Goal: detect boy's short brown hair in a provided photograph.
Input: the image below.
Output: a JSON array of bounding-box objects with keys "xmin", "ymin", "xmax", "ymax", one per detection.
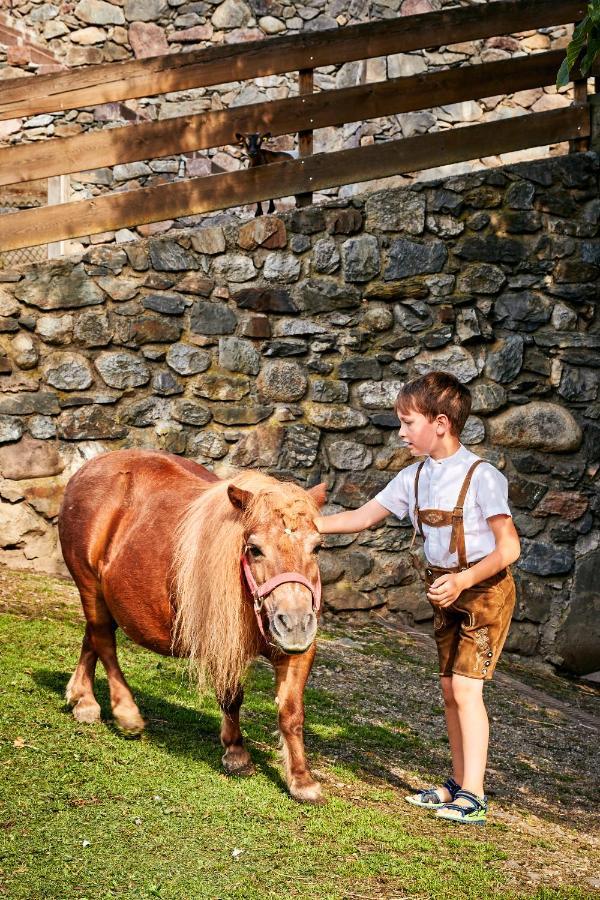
[{"xmin": 396, "ymin": 372, "xmax": 471, "ymax": 437}]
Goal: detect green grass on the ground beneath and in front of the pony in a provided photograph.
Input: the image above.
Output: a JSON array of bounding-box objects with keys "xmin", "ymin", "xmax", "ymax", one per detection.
[{"xmin": 0, "ymin": 615, "xmax": 590, "ymax": 900}]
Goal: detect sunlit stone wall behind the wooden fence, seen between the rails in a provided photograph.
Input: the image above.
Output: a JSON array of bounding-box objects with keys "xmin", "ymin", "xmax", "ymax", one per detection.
[{"xmin": 0, "ymin": 0, "xmax": 570, "ymax": 252}]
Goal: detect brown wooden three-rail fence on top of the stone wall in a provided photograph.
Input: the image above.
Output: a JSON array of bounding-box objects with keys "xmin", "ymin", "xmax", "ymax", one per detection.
[{"xmin": 0, "ymin": 0, "xmax": 590, "ymax": 250}]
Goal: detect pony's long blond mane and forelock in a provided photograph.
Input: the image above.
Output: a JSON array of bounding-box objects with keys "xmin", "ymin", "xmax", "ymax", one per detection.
[{"xmin": 173, "ymin": 470, "xmax": 317, "ymax": 700}]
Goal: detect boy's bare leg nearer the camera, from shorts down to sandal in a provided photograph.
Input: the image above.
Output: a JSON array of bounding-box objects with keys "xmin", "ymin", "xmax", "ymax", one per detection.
[{"xmin": 452, "ymin": 675, "xmax": 489, "ymax": 805}]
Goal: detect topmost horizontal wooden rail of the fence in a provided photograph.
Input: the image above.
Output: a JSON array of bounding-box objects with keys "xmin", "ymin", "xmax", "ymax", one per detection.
[{"xmin": 0, "ymin": 0, "xmax": 587, "ymax": 120}]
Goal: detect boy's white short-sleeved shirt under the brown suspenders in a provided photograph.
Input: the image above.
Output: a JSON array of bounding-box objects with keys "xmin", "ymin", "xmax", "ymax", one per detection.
[{"xmin": 375, "ymin": 444, "xmax": 511, "ymax": 569}]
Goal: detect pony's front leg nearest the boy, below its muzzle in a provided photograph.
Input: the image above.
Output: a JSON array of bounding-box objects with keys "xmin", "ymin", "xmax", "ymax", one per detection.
[{"xmin": 273, "ymin": 644, "xmax": 321, "ymax": 803}]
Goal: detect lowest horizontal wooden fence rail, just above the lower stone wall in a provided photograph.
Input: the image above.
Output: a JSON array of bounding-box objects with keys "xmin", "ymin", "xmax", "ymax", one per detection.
[{"xmin": 0, "ymin": 105, "xmax": 590, "ymax": 250}]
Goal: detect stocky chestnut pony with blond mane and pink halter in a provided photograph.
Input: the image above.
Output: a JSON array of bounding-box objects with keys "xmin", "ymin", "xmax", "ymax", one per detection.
[{"xmin": 59, "ymin": 450, "xmax": 325, "ymax": 802}]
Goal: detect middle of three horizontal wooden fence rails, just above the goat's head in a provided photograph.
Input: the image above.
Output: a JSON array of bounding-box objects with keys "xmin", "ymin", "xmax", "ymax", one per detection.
[{"xmin": 0, "ymin": 50, "xmax": 564, "ymax": 185}]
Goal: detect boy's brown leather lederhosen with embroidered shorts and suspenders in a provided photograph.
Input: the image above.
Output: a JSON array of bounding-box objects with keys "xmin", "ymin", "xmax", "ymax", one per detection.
[{"xmin": 413, "ymin": 459, "xmax": 515, "ymax": 680}]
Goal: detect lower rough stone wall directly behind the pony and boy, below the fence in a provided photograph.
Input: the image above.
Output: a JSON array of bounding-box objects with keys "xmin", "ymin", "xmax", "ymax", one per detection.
[{"xmin": 0, "ymin": 153, "xmax": 600, "ymax": 671}]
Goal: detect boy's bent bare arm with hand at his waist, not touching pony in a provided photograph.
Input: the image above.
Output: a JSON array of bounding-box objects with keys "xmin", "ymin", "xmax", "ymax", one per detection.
[{"xmin": 427, "ymin": 515, "xmax": 521, "ymax": 606}]
